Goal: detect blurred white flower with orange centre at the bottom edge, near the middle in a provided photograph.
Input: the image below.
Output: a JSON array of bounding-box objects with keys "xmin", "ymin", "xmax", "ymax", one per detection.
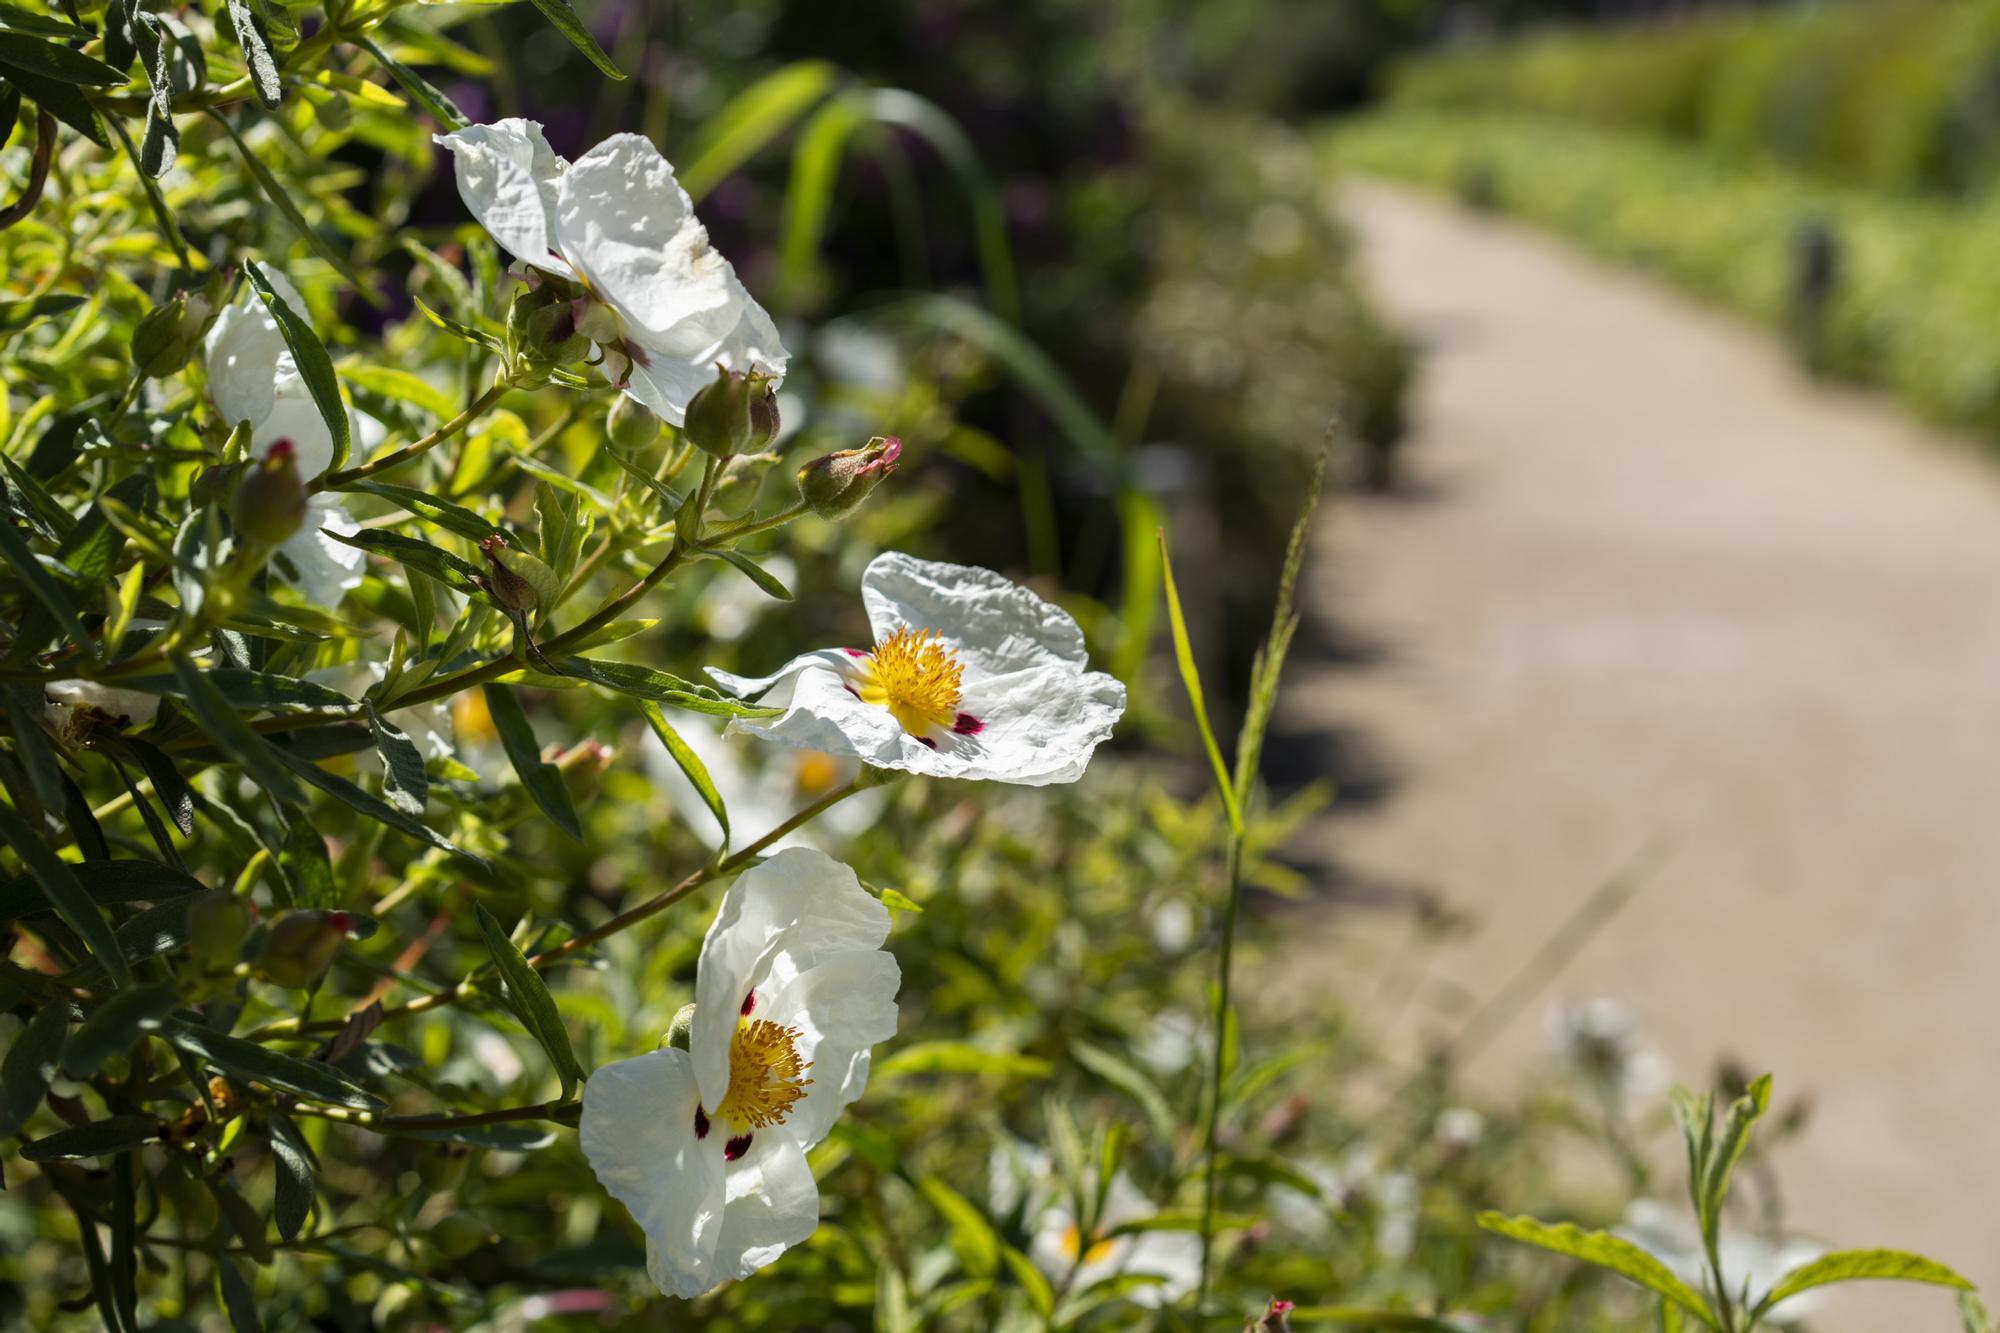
[{"xmin": 988, "ymin": 1143, "xmax": 1202, "ymax": 1309}]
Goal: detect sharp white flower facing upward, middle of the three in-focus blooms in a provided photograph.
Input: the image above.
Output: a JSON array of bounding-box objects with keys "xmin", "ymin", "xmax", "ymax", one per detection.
[{"xmin": 708, "ymin": 550, "xmax": 1124, "ymax": 787}]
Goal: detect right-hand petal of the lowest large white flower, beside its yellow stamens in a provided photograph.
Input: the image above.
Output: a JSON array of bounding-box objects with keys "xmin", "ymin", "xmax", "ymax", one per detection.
[{"xmin": 758, "ymin": 949, "xmax": 902, "ymax": 1149}]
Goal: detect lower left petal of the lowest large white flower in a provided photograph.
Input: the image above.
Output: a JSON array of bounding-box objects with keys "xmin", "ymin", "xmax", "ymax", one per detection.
[{"xmin": 576, "ymin": 1049, "xmax": 728, "ymax": 1297}]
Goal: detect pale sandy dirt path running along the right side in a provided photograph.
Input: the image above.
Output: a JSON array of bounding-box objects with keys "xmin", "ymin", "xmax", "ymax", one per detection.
[{"xmin": 1282, "ymin": 182, "xmax": 2000, "ymax": 1333}]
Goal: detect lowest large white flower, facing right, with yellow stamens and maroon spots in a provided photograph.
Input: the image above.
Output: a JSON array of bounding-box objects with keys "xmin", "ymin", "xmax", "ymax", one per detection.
[{"xmin": 578, "ymin": 849, "xmax": 902, "ymax": 1297}]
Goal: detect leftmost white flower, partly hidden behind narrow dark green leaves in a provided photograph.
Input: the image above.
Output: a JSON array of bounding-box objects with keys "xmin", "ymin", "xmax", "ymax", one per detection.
[{"xmin": 204, "ymin": 270, "xmax": 368, "ymax": 606}]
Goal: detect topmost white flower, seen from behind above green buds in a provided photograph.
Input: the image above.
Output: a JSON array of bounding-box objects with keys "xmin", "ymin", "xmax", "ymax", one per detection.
[{"xmin": 436, "ymin": 120, "xmax": 786, "ymax": 426}]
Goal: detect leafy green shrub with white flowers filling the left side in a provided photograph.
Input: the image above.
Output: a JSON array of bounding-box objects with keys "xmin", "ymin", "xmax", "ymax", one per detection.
[{"xmin": 0, "ymin": 0, "xmax": 1984, "ymax": 1333}]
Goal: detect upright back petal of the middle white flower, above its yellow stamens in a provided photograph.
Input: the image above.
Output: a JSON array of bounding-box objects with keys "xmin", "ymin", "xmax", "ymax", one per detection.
[{"xmin": 862, "ymin": 550, "xmax": 1088, "ymax": 681}]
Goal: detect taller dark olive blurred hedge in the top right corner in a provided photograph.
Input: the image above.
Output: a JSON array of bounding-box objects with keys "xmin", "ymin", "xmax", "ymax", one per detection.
[{"xmin": 1390, "ymin": 0, "xmax": 2000, "ymax": 196}]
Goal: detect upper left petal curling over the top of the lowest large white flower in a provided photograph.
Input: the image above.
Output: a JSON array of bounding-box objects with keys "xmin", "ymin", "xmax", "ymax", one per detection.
[{"xmin": 688, "ymin": 847, "xmax": 888, "ymax": 1109}]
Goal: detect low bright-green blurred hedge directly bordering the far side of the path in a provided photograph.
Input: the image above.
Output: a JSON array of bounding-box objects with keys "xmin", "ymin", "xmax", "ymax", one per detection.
[{"xmin": 1330, "ymin": 110, "xmax": 2000, "ymax": 436}]
